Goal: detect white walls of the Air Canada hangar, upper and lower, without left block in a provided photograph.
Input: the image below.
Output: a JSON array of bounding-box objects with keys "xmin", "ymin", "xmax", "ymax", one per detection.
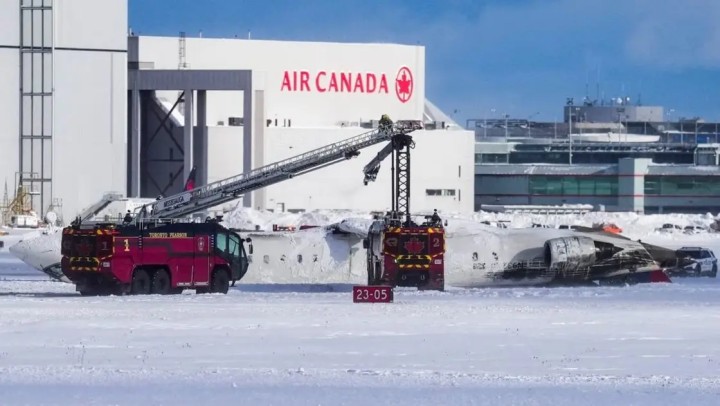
[{"xmin": 133, "ymin": 37, "xmax": 475, "ymax": 212}]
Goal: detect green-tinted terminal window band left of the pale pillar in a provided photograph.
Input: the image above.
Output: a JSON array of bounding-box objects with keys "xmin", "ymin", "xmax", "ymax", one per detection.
[{"xmin": 529, "ymin": 176, "xmax": 618, "ymax": 196}]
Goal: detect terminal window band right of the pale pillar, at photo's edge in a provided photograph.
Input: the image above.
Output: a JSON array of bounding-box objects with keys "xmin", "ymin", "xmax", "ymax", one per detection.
[{"xmin": 645, "ymin": 176, "xmax": 720, "ymax": 196}]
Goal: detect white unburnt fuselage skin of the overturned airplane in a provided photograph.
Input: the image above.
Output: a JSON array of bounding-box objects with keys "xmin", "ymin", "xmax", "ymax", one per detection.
[{"xmin": 10, "ymin": 221, "xmax": 660, "ymax": 287}]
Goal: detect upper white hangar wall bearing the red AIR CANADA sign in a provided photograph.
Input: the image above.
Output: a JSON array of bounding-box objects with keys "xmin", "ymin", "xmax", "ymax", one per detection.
[{"xmin": 133, "ymin": 36, "xmax": 425, "ymax": 127}]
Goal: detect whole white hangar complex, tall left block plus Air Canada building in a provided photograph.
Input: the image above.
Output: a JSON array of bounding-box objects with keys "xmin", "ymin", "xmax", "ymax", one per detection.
[{"xmin": 0, "ymin": 0, "xmax": 475, "ymax": 224}]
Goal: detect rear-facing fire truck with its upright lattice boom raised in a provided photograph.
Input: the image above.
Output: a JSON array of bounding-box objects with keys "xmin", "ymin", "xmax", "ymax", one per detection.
[{"xmin": 363, "ymin": 116, "xmax": 445, "ymax": 290}]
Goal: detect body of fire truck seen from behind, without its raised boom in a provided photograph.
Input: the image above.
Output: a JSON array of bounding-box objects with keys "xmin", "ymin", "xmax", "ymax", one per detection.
[{"xmin": 363, "ymin": 216, "xmax": 445, "ymax": 290}]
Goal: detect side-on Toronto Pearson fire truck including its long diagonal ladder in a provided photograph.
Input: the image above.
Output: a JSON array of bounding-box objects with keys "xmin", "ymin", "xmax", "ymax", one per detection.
[{"xmin": 61, "ymin": 116, "xmax": 418, "ymax": 295}]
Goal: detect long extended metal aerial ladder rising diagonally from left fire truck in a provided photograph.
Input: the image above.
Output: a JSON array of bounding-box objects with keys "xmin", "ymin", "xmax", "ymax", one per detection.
[{"xmin": 144, "ymin": 121, "xmax": 422, "ymax": 219}]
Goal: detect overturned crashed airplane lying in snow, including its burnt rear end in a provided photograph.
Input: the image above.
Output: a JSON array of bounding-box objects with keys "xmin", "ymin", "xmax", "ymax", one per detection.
[{"xmin": 9, "ymin": 219, "xmax": 692, "ymax": 288}]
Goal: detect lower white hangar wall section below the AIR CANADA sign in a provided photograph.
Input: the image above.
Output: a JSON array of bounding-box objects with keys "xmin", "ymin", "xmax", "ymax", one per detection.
[{"xmin": 255, "ymin": 128, "xmax": 475, "ymax": 213}]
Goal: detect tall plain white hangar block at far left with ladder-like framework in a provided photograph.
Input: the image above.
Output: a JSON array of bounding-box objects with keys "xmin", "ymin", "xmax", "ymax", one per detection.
[{"xmin": 0, "ymin": 0, "xmax": 127, "ymax": 220}]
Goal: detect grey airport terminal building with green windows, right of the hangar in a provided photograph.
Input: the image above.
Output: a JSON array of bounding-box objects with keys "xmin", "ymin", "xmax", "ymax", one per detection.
[{"xmin": 475, "ymin": 108, "xmax": 720, "ymax": 214}]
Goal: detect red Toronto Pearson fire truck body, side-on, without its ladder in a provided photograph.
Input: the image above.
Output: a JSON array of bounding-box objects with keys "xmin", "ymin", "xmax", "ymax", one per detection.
[{"xmin": 61, "ymin": 219, "xmax": 253, "ymax": 295}]
